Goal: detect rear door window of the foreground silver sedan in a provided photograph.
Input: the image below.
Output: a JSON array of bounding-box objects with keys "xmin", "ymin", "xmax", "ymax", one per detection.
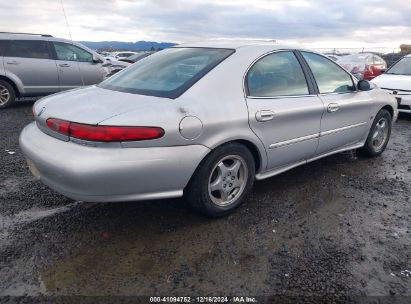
[{"xmin": 246, "ymin": 52, "xmax": 309, "ymax": 97}]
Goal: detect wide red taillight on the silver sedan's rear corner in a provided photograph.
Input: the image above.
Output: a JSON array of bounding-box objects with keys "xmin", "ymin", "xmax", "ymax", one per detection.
[{"xmin": 47, "ymin": 118, "xmax": 164, "ymax": 142}]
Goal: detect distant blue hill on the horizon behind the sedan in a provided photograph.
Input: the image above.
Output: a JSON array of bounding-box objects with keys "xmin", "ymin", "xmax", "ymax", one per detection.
[{"xmin": 79, "ymin": 41, "xmax": 176, "ymax": 51}]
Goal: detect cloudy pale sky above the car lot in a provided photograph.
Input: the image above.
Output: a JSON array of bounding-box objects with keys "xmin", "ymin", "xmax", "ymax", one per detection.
[{"xmin": 0, "ymin": 0, "xmax": 411, "ymax": 48}]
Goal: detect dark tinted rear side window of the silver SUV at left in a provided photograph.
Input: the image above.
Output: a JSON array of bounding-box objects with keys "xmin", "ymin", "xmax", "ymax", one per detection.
[{"xmin": 7, "ymin": 40, "xmax": 50, "ymax": 59}]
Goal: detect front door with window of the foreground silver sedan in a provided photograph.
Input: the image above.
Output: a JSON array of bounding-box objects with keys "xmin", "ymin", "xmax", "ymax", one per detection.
[{"xmin": 301, "ymin": 52, "xmax": 372, "ymax": 155}]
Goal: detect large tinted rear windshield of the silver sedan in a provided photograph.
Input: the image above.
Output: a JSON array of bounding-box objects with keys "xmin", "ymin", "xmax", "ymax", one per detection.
[{"xmin": 99, "ymin": 48, "xmax": 234, "ymax": 98}]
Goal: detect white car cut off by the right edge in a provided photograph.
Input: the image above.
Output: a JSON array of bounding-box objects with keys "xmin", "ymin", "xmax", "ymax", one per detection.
[{"xmin": 372, "ymin": 54, "xmax": 411, "ymax": 113}]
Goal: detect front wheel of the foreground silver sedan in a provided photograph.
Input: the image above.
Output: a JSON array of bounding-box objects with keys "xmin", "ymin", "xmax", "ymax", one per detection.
[{"xmin": 360, "ymin": 109, "xmax": 392, "ymax": 157}]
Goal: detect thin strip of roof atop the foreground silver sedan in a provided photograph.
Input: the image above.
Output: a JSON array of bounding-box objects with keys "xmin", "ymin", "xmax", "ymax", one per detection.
[{"xmin": 174, "ymin": 40, "xmax": 301, "ymax": 50}]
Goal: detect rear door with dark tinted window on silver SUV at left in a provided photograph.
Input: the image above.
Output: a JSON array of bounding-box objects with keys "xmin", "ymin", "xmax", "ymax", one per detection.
[{"xmin": 4, "ymin": 39, "xmax": 59, "ymax": 95}]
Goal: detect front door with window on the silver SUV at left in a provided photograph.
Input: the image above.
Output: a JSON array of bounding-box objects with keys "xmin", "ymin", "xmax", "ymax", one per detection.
[{"xmin": 51, "ymin": 41, "xmax": 103, "ymax": 90}]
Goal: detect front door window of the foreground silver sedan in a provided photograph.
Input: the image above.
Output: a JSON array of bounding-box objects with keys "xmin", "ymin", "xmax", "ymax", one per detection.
[{"xmin": 301, "ymin": 52, "xmax": 355, "ymax": 94}]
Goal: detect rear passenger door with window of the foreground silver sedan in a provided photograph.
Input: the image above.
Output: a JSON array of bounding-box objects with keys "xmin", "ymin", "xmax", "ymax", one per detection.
[{"xmin": 246, "ymin": 51, "xmax": 324, "ymax": 170}]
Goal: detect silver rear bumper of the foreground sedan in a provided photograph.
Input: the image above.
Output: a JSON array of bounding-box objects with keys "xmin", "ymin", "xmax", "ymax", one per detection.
[{"xmin": 20, "ymin": 123, "xmax": 209, "ymax": 202}]
